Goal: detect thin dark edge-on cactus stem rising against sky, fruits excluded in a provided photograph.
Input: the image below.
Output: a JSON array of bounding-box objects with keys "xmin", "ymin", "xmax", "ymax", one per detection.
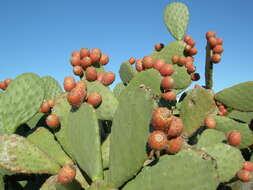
[{"xmin": 205, "ymin": 43, "xmax": 213, "ymax": 89}]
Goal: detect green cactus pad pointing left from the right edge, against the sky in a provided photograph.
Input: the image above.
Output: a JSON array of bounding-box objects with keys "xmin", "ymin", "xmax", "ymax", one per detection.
[{"xmin": 215, "ymin": 81, "xmax": 253, "ymax": 111}]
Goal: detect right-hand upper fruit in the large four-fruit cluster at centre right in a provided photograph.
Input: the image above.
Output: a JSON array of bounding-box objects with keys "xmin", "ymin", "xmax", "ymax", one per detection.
[{"xmin": 167, "ymin": 116, "xmax": 184, "ymax": 137}]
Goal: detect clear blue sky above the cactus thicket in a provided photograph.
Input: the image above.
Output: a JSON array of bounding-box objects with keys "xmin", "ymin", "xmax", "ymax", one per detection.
[{"xmin": 0, "ymin": 0, "xmax": 253, "ymax": 92}]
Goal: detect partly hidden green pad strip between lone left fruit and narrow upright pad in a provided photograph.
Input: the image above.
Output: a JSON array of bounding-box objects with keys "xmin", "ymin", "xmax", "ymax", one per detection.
[{"xmin": 52, "ymin": 94, "xmax": 72, "ymax": 155}]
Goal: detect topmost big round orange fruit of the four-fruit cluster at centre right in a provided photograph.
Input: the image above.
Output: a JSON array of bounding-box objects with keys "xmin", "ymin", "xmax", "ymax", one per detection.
[{"xmin": 152, "ymin": 107, "xmax": 172, "ymax": 130}]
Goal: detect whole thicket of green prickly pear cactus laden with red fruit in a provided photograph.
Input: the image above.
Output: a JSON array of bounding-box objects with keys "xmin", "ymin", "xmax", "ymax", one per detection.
[{"xmin": 0, "ymin": 2, "xmax": 253, "ymax": 190}]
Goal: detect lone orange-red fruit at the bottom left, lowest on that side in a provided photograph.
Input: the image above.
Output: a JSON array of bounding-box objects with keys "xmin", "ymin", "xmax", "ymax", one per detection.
[{"xmin": 57, "ymin": 165, "xmax": 76, "ymax": 184}]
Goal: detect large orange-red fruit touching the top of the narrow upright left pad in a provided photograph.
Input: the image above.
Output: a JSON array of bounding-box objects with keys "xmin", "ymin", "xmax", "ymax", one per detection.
[{"xmin": 67, "ymin": 87, "xmax": 87, "ymax": 106}]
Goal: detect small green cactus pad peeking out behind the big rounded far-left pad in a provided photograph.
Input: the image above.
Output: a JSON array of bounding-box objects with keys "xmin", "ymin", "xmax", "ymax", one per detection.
[{"xmin": 41, "ymin": 76, "xmax": 62, "ymax": 100}]
